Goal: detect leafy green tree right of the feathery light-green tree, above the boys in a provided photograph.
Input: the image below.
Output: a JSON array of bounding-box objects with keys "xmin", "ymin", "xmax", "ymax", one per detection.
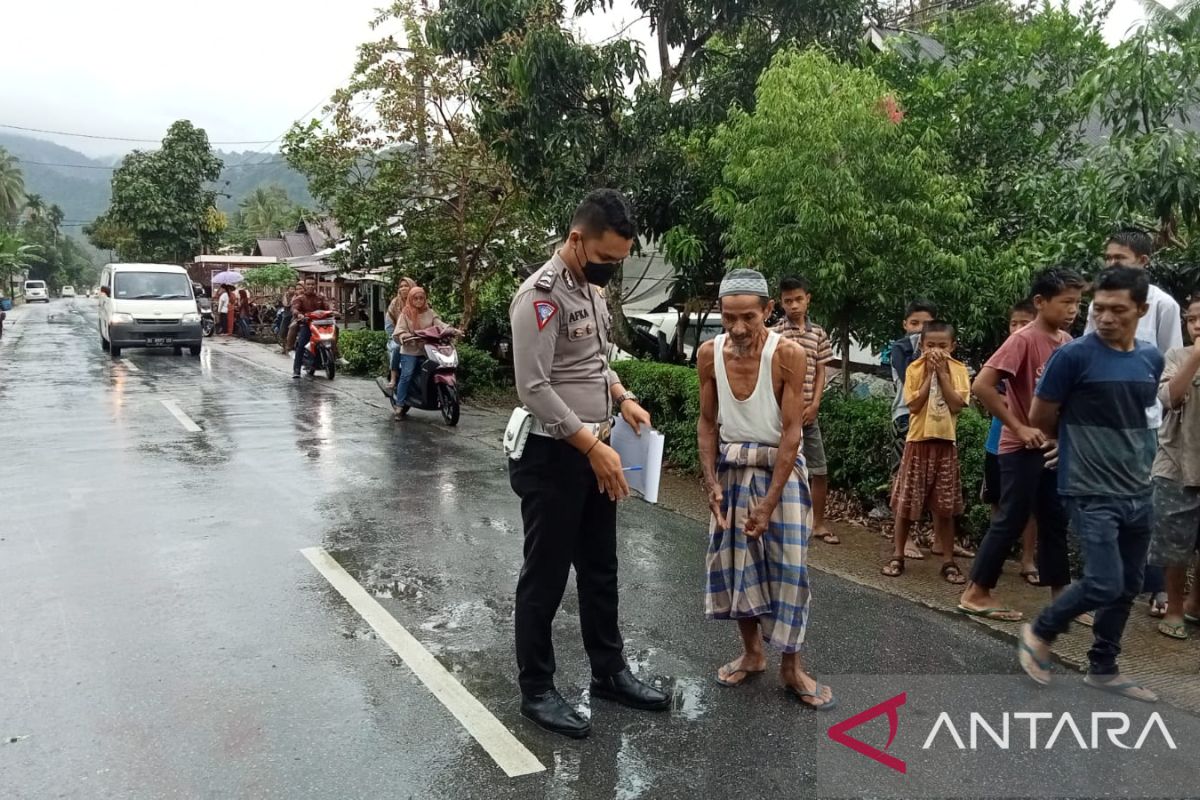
[{"xmin": 868, "ymin": 2, "xmax": 1109, "ymax": 347}]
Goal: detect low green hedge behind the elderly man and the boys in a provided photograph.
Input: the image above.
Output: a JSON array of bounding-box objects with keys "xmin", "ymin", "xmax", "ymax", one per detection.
[{"xmin": 613, "ymin": 361, "xmax": 990, "ymax": 542}]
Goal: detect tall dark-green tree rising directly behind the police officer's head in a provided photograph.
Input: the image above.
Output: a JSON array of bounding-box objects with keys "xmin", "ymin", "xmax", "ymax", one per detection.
[{"xmin": 431, "ymin": 0, "xmax": 866, "ymax": 347}]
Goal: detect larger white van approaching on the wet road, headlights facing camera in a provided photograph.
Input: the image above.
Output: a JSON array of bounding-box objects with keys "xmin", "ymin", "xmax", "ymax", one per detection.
[{"xmin": 100, "ymin": 264, "xmax": 204, "ymax": 359}]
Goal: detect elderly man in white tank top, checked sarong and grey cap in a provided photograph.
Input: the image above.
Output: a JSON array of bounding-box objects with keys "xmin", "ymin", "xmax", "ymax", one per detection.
[{"xmin": 698, "ymin": 270, "xmax": 836, "ymax": 711}]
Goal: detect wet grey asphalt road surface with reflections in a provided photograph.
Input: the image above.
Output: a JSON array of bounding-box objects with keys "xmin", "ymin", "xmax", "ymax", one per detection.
[{"xmin": 0, "ymin": 299, "xmax": 1200, "ymax": 800}]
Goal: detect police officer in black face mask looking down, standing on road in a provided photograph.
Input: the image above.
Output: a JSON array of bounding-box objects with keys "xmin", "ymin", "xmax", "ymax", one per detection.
[{"xmin": 509, "ymin": 190, "xmax": 671, "ymax": 739}]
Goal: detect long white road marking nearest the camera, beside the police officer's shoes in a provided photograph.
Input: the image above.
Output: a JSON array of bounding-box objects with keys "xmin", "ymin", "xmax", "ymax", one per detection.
[{"xmin": 300, "ymin": 547, "xmax": 546, "ymax": 777}]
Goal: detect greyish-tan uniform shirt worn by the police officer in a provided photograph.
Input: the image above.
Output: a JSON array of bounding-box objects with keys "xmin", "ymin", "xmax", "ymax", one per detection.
[{"xmin": 509, "ymin": 253, "xmax": 617, "ymax": 439}]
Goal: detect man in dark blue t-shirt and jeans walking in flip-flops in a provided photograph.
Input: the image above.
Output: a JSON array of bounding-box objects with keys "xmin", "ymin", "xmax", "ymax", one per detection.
[{"xmin": 1018, "ymin": 267, "xmax": 1163, "ymax": 703}]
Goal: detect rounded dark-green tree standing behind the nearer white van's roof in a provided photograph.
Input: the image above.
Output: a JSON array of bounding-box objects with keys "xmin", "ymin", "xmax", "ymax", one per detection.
[{"xmin": 85, "ymin": 120, "xmax": 221, "ymax": 263}]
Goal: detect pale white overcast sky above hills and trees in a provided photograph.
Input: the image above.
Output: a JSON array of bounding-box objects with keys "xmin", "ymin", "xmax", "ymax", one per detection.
[{"xmin": 0, "ymin": 0, "xmax": 1139, "ymax": 156}]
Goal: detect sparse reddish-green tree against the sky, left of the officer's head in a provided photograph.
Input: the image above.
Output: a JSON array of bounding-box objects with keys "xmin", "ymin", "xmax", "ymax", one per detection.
[{"xmin": 283, "ymin": 1, "xmax": 546, "ymax": 327}]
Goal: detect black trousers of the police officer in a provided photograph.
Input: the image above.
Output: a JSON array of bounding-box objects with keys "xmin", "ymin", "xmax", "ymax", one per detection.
[{"xmin": 509, "ymin": 435, "xmax": 625, "ymax": 696}]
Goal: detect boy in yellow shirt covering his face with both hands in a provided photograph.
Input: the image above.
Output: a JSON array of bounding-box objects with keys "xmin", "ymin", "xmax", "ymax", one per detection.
[{"xmin": 883, "ymin": 320, "xmax": 971, "ymax": 584}]
